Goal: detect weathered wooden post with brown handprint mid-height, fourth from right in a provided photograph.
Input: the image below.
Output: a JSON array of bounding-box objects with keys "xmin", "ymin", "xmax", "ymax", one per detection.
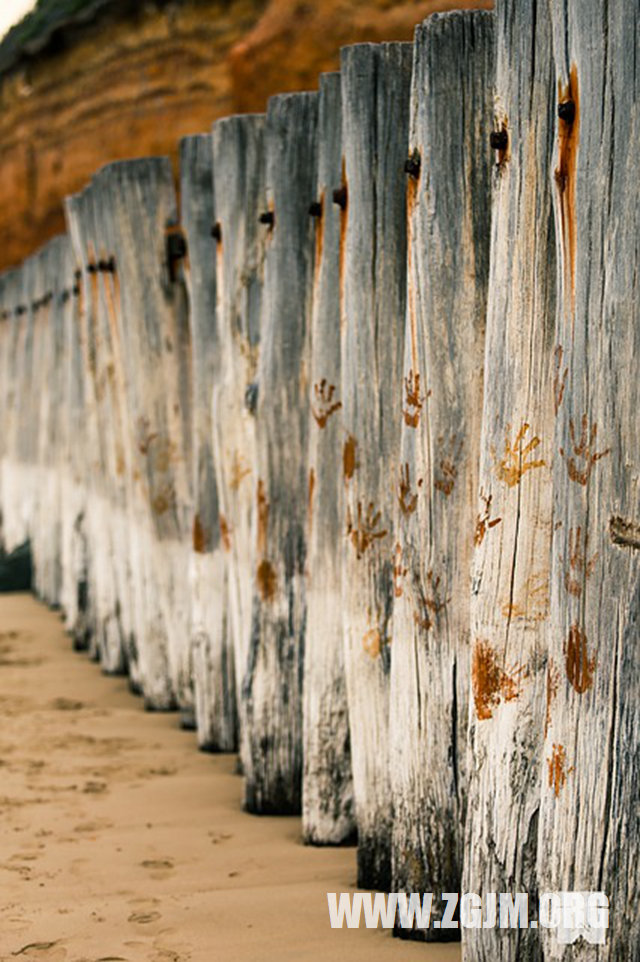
[{"xmin": 334, "ymin": 43, "xmax": 412, "ymax": 891}]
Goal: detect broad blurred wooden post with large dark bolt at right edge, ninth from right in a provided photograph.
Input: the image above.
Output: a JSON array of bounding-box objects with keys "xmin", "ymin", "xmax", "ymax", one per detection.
[{"xmin": 90, "ymin": 158, "xmax": 193, "ymax": 711}]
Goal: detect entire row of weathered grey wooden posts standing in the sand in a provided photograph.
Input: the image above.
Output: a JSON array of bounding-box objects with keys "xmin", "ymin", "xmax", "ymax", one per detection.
[{"xmin": 0, "ymin": 0, "xmax": 640, "ymax": 962}]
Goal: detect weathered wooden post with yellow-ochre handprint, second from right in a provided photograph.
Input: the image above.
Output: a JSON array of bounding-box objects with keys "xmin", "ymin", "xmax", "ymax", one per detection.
[{"xmin": 463, "ymin": 0, "xmax": 556, "ymax": 962}]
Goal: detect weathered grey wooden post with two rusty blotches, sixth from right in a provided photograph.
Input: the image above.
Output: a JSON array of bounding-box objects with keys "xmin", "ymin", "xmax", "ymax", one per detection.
[{"xmin": 244, "ymin": 93, "xmax": 318, "ymax": 814}]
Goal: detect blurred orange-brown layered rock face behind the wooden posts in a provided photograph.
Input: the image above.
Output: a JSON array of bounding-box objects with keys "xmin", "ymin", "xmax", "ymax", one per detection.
[{"xmin": 0, "ymin": 0, "xmax": 491, "ymax": 270}]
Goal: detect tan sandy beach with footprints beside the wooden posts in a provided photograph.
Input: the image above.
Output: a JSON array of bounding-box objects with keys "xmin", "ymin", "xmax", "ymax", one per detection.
[{"xmin": 0, "ymin": 595, "xmax": 460, "ymax": 962}]
